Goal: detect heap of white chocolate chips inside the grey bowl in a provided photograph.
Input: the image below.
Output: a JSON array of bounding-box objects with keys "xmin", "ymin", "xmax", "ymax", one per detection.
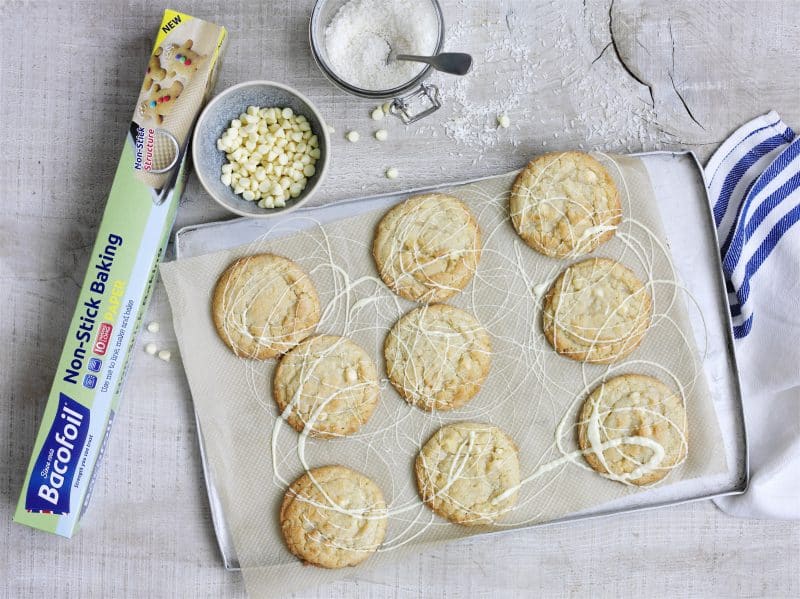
[{"xmin": 217, "ymin": 106, "xmax": 322, "ymax": 208}]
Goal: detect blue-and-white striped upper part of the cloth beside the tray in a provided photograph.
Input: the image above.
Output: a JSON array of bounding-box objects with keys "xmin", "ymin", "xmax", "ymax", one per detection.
[{"xmin": 706, "ymin": 112, "xmax": 800, "ymax": 339}]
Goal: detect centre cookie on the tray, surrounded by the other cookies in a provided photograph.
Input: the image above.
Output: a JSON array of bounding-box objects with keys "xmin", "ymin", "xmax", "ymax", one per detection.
[{"xmin": 383, "ymin": 304, "xmax": 492, "ymax": 411}]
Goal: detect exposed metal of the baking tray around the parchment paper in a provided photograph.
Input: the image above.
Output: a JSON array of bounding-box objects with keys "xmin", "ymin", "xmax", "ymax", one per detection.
[{"xmin": 175, "ymin": 151, "xmax": 748, "ymax": 570}]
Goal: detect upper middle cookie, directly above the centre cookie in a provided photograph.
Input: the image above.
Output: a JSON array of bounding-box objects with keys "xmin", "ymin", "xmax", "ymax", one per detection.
[{"xmin": 372, "ymin": 193, "xmax": 481, "ymax": 304}]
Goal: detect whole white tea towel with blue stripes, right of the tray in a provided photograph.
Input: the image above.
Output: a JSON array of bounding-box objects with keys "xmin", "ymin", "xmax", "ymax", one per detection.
[{"xmin": 705, "ymin": 112, "xmax": 800, "ymax": 519}]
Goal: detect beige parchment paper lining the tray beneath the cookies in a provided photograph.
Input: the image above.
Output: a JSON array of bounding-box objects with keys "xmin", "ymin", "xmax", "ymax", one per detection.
[{"xmin": 161, "ymin": 155, "xmax": 727, "ymax": 596}]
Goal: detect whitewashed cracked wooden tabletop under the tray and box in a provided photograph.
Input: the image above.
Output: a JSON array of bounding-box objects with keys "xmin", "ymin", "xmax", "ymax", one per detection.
[{"xmin": 0, "ymin": 0, "xmax": 800, "ymax": 597}]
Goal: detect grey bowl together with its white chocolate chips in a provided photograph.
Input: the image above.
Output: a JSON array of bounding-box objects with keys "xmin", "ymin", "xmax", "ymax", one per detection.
[{"xmin": 192, "ymin": 81, "xmax": 329, "ymax": 218}]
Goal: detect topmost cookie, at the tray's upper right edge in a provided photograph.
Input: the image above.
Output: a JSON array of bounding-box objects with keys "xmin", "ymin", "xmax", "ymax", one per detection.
[{"xmin": 509, "ymin": 152, "xmax": 622, "ymax": 258}]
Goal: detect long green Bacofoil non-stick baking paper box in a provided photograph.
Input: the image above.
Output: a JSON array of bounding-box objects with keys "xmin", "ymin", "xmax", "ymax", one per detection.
[{"xmin": 14, "ymin": 10, "xmax": 226, "ymax": 537}]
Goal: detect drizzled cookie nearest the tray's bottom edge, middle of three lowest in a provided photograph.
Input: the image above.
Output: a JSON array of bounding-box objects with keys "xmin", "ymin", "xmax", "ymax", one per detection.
[{"xmin": 415, "ymin": 422, "xmax": 520, "ymax": 525}]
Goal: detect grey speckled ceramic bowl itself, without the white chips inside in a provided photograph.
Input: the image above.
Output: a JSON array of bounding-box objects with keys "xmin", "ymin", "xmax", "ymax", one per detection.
[{"xmin": 192, "ymin": 81, "xmax": 330, "ymax": 218}]
